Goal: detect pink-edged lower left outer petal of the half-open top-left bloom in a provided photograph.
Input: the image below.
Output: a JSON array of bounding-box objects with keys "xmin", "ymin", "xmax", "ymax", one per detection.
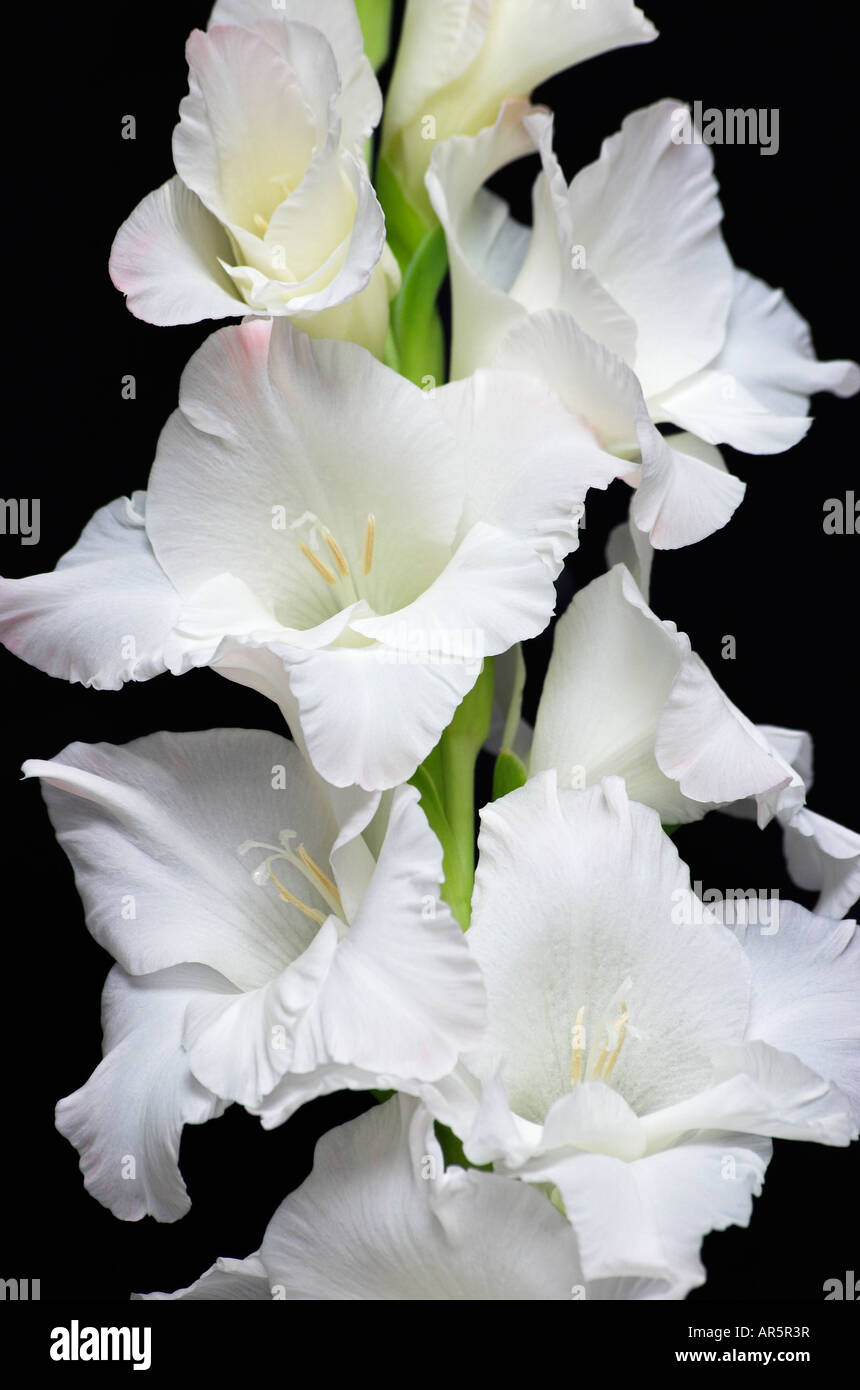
[{"xmin": 110, "ymin": 178, "xmax": 241, "ymax": 324}]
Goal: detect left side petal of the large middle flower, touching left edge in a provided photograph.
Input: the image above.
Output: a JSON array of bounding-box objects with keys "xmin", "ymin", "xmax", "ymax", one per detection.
[{"xmin": 0, "ymin": 495, "xmax": 179, "ymax": 689}]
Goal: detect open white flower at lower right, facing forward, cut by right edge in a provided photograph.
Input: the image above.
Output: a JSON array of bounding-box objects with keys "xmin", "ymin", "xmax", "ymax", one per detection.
[{"xmin": 422, "ymin": 773, "xmax": 860, "ymax": 1295}]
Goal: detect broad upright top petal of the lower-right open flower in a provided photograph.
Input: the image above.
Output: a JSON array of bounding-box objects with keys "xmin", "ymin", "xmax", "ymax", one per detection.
[{"xmin": 467, "ymin": 773, "xmax": 749, "ymax": 1123}]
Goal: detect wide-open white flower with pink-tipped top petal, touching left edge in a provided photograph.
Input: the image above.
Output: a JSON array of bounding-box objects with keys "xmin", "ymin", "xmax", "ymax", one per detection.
[{"xmin": 0, "ymin": 320, "xmax": 617, "ymax": 790}]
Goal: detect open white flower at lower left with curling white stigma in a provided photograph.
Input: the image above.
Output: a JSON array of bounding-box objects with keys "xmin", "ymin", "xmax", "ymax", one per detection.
[{"xmin": 24, "ymin": 730, "xmax": 485, "ymax": 1220}]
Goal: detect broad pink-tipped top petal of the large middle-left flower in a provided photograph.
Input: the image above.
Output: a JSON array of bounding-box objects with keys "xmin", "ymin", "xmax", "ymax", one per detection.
[{"xmin": 149, "ymin": 320, "xmax": 464, "ymax": 628}]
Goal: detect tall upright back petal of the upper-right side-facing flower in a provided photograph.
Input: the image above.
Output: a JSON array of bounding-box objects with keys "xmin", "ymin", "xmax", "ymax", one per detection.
[{"xmin": 570, "ymin": 100, "xmax": 732, "ymax": 396}]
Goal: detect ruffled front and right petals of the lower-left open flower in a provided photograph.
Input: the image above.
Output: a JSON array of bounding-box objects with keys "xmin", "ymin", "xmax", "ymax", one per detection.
[{"xmin": 185, "ymin": 787, "xmax": 483, "ymax": 1109}]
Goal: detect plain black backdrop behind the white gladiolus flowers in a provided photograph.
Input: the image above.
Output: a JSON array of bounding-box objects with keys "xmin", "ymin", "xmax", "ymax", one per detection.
[{"xmin": 0, "ymin": 0, "xmax": 860, "ymax": 1301}]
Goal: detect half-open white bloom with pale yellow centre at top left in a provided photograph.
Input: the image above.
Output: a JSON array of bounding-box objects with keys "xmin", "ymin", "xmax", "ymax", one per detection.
[{"xmin": 110, "ymin": 9, "xmax": 399, "ymax": 354}]
